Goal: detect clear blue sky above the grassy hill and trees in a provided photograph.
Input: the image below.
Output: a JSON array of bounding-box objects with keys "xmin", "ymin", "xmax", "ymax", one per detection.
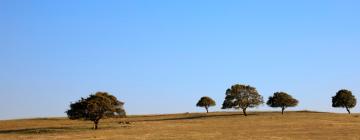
[{"xmin": 0, "ymin": 0, "xmax": 360, "ymax": 119}]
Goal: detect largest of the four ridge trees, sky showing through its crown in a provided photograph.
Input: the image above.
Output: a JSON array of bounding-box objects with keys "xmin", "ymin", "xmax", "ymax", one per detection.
[{"xmin": 222, "ymin": 84, "xmax": 264, "ymax": 116}]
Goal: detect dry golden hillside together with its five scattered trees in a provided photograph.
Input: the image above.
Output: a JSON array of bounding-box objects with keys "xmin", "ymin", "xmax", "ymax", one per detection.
[{"xmin": 0, "ymin": 84, "xmax": 360, "ymax": 140}]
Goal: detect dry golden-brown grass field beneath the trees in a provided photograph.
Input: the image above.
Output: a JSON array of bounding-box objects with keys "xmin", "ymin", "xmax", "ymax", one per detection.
[{"xmin": 0, "ymin": 111, "xmax": 360, "ymax": 140}]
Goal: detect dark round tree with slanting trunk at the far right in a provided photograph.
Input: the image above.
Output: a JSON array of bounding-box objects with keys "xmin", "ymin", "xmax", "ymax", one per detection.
[{"xmin": 332, "ymin": 89, "xmax": 356, "ymax": 114}]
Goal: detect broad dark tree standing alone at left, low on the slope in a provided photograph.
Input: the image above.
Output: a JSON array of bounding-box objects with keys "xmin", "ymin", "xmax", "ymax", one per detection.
[{"xmin": 66, "ymin": 92, "xmax": 124, "ymax": 129}]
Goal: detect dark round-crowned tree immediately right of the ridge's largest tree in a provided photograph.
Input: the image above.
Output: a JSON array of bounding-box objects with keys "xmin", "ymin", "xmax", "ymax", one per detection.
[{"xmin": 266, "ymin": 92, "xmax": 298, "ymax": 114}]
